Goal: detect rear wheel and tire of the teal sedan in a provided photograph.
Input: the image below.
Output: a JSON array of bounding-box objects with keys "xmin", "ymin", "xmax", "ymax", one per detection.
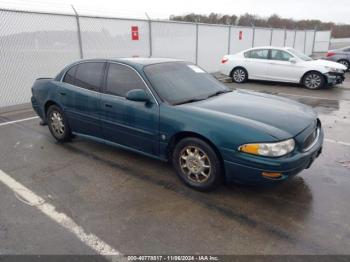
[{"xmin": 46, "ymin": 105, "xmax": 72, "ymax": 142}]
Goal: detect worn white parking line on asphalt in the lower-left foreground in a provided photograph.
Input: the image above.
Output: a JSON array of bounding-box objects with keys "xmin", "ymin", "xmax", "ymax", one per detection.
[{"xmin": 0, "ymin": 170, "xmax": 122, "ymax": 261}]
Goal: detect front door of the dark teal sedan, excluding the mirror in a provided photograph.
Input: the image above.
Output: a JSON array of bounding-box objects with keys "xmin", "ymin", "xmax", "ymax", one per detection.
[{"xmin": 101, "ymin": 63, "xmax": 159, "ymax": 155}]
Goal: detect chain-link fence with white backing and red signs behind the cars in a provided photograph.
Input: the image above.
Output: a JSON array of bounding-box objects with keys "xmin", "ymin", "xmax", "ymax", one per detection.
[{"xmin": 0, "ymin": 9, "xmax": 330, "ymax": 108}]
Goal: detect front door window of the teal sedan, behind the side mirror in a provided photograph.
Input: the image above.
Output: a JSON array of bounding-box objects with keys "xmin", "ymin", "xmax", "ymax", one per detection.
[{"xmin": 105, "ymin": 63, "xmax": 146, "ymax": 97}]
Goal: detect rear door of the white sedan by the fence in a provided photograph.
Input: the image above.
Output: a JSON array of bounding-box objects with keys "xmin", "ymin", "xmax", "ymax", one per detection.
[{"xmin": 244, "ymin": 49, "xmax": 269, "ymax": 80}]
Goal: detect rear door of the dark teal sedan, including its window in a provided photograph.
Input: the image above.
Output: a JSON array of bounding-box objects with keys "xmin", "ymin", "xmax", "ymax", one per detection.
[{"xmin": 59, "ymin": 62, "xmax": 106, "ymax": 137}]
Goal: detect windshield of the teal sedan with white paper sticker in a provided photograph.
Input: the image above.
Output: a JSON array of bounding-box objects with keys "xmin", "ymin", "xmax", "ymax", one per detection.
[{"xmin": 144, "ymin": 62, "xmax": 231, "ymax": 105}]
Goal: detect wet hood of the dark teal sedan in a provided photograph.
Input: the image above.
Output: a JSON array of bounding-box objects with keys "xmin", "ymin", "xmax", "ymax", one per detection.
[{"xmin": 183, "ymin": 90, "xmax": 317, "ymax": 140}]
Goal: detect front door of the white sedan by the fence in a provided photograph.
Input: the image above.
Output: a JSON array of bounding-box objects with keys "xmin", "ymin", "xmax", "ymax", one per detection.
[{"xmin": 266, "ymin": 49, "xmax": 303, "ymax": 83}]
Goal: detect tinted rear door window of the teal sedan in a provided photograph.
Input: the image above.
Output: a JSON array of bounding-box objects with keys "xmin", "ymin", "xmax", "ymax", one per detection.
[{"xmin": 75, "ymin": 62, "xmax": 105, "ymax": 91}]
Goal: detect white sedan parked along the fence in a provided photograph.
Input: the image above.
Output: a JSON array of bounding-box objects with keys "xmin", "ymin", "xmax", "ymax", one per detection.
[{"xmin": 220, "ymin": 46, "xmax": 346, "ymax": 89}]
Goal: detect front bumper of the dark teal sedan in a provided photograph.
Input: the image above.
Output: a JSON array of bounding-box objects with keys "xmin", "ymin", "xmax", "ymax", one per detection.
[{"xmin": 224, "ymin": 129, "xmax": 324, "ymax": 185}]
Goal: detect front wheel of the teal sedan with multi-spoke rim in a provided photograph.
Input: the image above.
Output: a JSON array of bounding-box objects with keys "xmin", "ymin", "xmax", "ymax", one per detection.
[{"xmin": 172, "ymin": 137, "xmax": 222, "ymax": 191}]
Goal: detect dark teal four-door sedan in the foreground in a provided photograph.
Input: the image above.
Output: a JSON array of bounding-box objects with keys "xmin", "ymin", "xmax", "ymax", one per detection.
[{"xmin": 31, "ymin": 58, "xmax": 323, "ymax": 190}]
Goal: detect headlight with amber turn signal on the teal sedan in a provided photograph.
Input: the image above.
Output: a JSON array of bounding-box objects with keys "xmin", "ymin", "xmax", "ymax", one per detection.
[{"xmin": 238, "ymin": 139, "xmax": 295, "ymax": 157}]
